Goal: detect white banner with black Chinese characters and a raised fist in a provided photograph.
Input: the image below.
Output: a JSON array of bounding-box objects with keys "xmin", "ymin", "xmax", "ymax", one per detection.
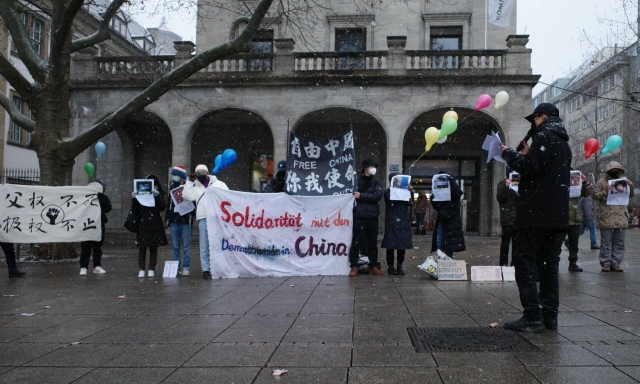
[{"xmin": 0, "ymin": 184, "xmax": 102, "ymax": 243}]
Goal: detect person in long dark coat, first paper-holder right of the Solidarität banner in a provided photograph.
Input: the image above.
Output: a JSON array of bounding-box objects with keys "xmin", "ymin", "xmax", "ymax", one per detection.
[{"xmin": 382, "ymin": 173, "xmax": 413, "ymax": 275}]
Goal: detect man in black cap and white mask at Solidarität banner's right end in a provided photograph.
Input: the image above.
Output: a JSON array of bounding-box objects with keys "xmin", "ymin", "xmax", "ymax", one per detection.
[{"xmin": 349, "ymin": 159, "xmax": 384, "ymax": 277}]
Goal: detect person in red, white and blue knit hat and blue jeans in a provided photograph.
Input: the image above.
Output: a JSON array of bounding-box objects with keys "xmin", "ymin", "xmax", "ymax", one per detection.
[{"xmin": 164, "ymin": 165, "xmax": 193, "ymax": 276}]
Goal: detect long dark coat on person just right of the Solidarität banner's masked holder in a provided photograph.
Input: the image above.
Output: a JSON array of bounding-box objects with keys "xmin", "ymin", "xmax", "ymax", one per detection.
[{"xmin": 382, "ymin": 188, "xmax": 413, "ymax": 249}]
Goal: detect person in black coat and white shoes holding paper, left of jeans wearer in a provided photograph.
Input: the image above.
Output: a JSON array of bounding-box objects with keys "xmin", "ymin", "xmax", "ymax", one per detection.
[{"xmin": 131, "ymin": 175, "xmax": 168, "ymax": 277}]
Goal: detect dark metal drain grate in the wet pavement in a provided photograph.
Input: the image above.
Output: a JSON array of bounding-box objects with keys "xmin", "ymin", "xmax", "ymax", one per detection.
[{"xmin": 407, "ymin": 327, "xmax": 540, "ymax": 353}]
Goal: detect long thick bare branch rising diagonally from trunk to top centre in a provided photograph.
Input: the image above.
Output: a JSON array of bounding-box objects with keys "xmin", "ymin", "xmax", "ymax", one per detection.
[{"xmin": 59, "ymin": 0, "xmax": 273, "ymax": 159}]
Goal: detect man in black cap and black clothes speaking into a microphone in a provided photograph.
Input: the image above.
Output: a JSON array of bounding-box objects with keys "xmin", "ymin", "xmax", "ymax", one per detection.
[{"xmin": 501, "ymin": 103, "xmax": 571, "ymax": 332}]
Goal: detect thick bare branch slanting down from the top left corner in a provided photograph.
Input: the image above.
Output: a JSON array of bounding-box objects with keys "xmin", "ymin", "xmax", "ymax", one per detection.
[{"xmin": 0, "ymin": 0, "xmax": 47, "ymax": 82}]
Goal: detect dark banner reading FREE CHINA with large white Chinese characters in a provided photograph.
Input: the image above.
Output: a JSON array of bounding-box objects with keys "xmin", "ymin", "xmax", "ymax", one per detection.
[{"xmin": 285, "ymin": 131, "xmax": 357, "ymax": 196}]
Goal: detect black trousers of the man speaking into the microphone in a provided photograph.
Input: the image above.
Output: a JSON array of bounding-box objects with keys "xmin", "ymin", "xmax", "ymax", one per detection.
[{"xmin": 513, "ymin": 228, "xmax": 560, "ymax": 320}]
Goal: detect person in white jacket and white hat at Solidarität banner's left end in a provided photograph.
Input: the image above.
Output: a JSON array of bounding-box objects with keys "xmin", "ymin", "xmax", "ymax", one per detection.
[{"xmin": 182, "ymin": 164, "xmax": 229, "ymax": 280}]
